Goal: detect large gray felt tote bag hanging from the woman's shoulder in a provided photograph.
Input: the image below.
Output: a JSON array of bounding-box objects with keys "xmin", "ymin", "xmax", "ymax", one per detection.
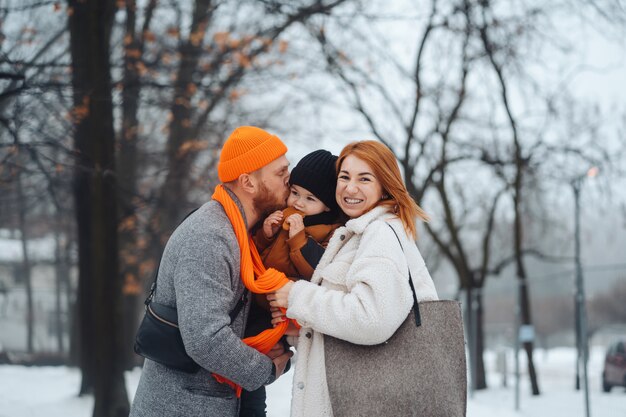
[{"xmin": 324, "ymin": 228, "xmax": 467, "ymax": 417}]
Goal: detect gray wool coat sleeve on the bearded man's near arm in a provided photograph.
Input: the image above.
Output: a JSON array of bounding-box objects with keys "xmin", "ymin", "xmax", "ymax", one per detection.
[{"xmin": 174, "ymin": 231, "xmax": 272, "ymax": 390}]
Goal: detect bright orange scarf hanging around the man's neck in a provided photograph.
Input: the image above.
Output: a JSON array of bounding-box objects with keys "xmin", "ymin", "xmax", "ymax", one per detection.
[{"xmin": 212, "ymin": 185, "xmax": 300, "ymax": 398}]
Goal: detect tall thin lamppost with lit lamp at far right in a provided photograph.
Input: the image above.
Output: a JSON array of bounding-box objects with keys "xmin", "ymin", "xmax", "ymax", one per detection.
[{"xmin": 570, "ymin": 167, "xmax": 598, "ymax": 417}]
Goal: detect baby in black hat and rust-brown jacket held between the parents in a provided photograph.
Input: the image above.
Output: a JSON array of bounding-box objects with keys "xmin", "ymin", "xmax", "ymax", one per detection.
[{"xmin": 239, "ymin": 149, "xmax": 341, "ymax": 417}]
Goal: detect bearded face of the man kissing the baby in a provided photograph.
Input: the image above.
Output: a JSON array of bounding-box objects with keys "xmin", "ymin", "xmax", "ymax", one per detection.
[{"xmin": 252, "ymin": 155, "xmax": 289, "ymax": 216}]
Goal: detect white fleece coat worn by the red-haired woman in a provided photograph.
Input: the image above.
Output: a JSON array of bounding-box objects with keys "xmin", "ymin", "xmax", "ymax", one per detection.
[{"xmin": 287, "ymin": 207, "xmax": 438, "ymax": 417}]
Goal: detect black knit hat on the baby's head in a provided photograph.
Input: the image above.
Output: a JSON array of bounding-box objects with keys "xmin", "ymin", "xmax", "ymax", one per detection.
[{"xmin": 289, "ymin": 149, "xmax": 339, "ymax": 212}]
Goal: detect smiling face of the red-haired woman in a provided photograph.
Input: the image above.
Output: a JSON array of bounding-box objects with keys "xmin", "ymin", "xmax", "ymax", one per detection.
[{"xmin": 335, "ymin": 155, "xmax": 383, "ymax": 219}]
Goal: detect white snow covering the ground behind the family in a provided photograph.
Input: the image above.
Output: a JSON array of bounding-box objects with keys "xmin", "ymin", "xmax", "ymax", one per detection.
[{"xmin": 0, "ymin": 348, "xmax": 626, "ymax": 417}]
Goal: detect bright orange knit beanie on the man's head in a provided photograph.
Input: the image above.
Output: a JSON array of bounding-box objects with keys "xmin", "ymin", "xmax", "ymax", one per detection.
[{"xmin": 217, "ymin": 126, "xmax": 287, "ymax": 182}]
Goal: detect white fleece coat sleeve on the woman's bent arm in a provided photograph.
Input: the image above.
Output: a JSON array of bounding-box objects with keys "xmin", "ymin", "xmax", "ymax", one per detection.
[{"xmin": 287, "ymin": 221, "xmax": 413, "ymax": 345}]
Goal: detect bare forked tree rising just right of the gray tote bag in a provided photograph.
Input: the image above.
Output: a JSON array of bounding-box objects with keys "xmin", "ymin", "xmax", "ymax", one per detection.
[{"xmin": 308, "ymin": 1, "xmax": 508, "ymax": 389}]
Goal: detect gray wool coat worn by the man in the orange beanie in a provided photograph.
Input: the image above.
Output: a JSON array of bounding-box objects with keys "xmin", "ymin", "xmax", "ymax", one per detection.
[{"xmin": 130, "ymin": 193, "xmax": 272, "ymax": 417}]
